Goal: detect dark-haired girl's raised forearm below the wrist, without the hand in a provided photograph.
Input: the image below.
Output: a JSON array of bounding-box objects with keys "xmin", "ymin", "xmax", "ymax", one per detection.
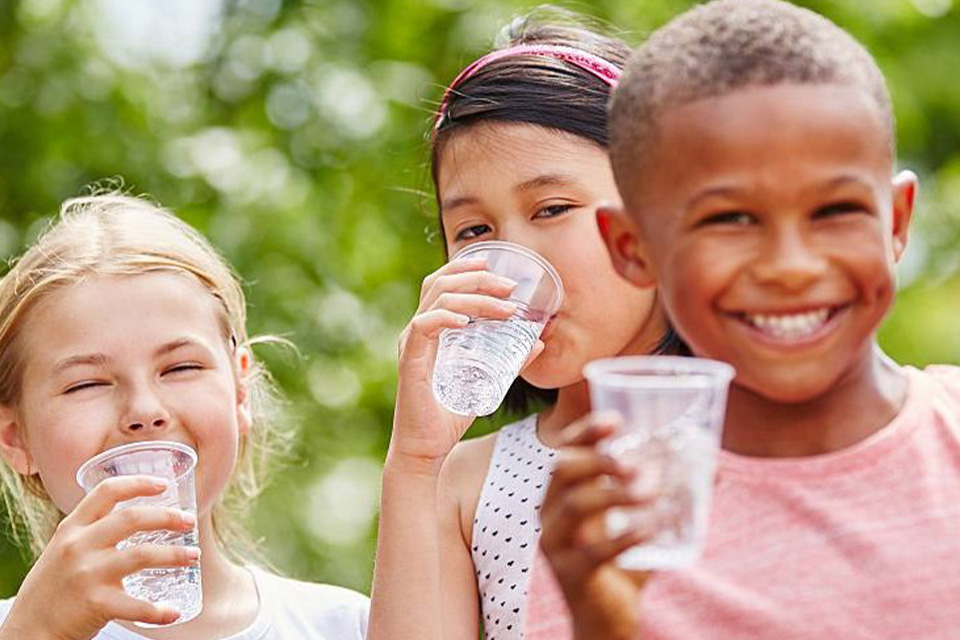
[{"xmin": 367, "ymin": 456, "xmax": 442, "ymax": 640}]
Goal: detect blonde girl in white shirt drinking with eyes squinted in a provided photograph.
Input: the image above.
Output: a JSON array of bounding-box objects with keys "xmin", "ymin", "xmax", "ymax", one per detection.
[{"xmin": 0, "ymin": 195, "xmax": 367, "ymax": 640}]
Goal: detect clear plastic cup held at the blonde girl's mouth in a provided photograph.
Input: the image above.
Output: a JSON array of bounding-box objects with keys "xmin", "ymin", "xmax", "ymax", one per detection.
[{"xmin": 77, "ymin": 441, "xmax": 203, "ymax": 627}]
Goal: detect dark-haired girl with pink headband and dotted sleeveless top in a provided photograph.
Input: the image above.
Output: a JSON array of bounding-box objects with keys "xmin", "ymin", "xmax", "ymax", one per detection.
[{"xmin": 371, "ymin": 12, "xmax": 684, "ymax": 640}]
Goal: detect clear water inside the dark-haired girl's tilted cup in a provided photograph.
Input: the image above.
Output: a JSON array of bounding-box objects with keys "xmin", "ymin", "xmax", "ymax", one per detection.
[{"xmin": 433, "ymin": 316, "xmax": 543, "ymax": 416}]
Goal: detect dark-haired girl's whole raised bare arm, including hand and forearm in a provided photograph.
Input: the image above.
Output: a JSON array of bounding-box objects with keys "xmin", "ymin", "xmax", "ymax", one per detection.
[{"xmin": 367, "ymin": 261, "xmax": 512, "ymax": 640}]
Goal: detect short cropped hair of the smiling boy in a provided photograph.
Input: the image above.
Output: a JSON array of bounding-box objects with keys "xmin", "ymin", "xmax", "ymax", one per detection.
[{"xmin": 610, "ymin": 0, "xmax": 895, "ymax": 202}]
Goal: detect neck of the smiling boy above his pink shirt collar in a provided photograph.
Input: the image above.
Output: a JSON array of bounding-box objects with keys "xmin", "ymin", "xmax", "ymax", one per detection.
[{"xmin": 723, "ymin": 345, "xmax": 907, "ymax": 458}]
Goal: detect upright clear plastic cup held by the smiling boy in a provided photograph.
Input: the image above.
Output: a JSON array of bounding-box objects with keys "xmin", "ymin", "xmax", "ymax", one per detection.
[{"xmin": 584, "ymin": 356, "xmax": 734, "ymax": 570}]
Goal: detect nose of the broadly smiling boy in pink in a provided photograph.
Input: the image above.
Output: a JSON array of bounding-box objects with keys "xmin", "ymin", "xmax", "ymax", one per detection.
[{"xmin": 753, "ymin": 229, "xmax": 829, "ymax": 291}]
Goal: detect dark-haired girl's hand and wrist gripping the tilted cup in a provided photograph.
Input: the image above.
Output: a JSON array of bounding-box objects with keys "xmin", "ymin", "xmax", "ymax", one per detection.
[{"xmin": 389, "ymin": 259, "xmax": 542, "ymax": 473}]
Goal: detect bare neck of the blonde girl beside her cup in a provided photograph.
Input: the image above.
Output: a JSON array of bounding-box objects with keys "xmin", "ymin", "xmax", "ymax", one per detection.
[{"xmin": 121, "ymin": 513, "xmax": 259, "ymax": 640}]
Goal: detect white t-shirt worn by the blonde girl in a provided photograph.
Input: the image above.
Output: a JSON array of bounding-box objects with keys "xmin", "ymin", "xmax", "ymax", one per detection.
[{"xmin": 0, "ymin": 567, "xmax": 370, "ymax": 640}]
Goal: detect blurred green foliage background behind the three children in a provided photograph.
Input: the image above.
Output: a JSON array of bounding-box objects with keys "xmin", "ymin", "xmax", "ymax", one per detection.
[{"xmin": 0, "ymin": 0, "xmax": 960, "ymax": 597}]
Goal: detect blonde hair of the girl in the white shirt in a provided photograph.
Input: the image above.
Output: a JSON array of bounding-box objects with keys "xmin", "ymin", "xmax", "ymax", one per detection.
[{"xmin": 0, "ymin": 193, "xmax": 290, "ymax": 560}]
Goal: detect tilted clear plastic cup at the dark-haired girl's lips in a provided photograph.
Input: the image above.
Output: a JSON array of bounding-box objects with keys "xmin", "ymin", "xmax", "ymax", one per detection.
[{"xmin": 433, "ymin": 242, "xmax": 563, "ymax": 416}]
